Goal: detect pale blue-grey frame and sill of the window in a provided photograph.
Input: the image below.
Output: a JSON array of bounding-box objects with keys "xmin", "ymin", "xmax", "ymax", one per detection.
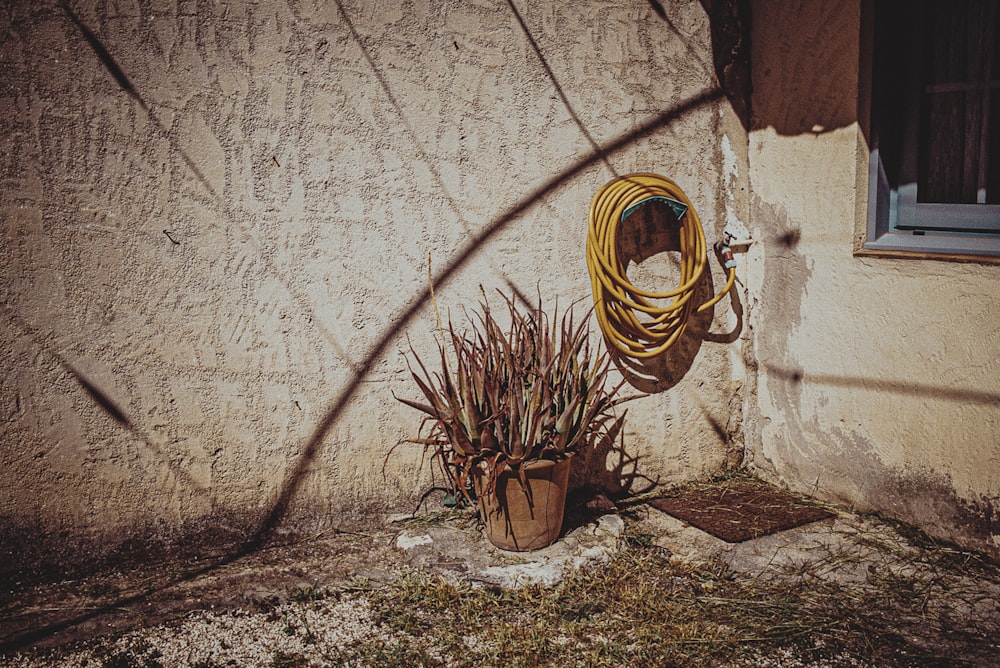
[{"xmin": 855, "ymin": 0, "xmax": 1000, "ymax": 261}]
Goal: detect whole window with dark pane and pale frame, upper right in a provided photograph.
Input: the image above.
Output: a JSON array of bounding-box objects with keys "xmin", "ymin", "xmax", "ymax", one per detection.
[{"xmin": 864, "ymin": 0, "xmax": 1000, "ymax": 257}]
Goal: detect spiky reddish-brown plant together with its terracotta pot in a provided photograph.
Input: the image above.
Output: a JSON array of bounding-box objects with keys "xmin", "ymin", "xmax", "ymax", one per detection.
[{"xmin": 397, "ymin": 295, "xmax": 624, "ymax": 551}]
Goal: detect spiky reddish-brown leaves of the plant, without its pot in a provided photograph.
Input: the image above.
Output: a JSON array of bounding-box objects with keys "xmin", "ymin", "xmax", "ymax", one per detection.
[{"xmin": 396, "ymin": 295, "xmax": 624, "ymax": 501}]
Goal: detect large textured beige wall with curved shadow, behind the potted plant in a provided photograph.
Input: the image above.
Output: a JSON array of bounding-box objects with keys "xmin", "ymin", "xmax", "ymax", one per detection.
[{"xmin": 0, "ymin": 0, "xmax": 752, "ymax": 576}]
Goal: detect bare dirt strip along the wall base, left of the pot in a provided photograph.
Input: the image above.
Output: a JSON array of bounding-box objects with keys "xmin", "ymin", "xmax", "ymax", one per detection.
[{"xmin": 0, "ymin": 528, "xmax": 404, "ymax": 656}]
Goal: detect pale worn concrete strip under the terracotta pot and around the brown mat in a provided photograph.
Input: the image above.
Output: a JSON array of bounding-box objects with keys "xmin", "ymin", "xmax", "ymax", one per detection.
[{"xmin": 395, "ymin": 490, "xmax": 944, "ymax": 587}]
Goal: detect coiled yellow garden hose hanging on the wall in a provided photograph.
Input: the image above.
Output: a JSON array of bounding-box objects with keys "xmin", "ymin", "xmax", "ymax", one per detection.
[{"xmin": 587, "ymin": 173, "xmax": 736, "ymax": 358}]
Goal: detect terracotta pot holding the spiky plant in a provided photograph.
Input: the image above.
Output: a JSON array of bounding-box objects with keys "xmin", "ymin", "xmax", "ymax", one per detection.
[{"xmin": 474, "ymin": 458, "xmax": 570, "ymax": 552}]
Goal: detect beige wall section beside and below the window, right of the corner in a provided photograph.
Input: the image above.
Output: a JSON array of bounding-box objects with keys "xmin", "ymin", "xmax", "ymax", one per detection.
[{"xmin": 746, "ymin": 1, "xmax": 1000, "ymax": 554}]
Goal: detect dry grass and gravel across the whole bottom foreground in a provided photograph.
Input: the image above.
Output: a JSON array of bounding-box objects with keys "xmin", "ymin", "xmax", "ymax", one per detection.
[{"xmin": 8, "ymin": 506, "xmax": 1000, "ymax": 668}]
